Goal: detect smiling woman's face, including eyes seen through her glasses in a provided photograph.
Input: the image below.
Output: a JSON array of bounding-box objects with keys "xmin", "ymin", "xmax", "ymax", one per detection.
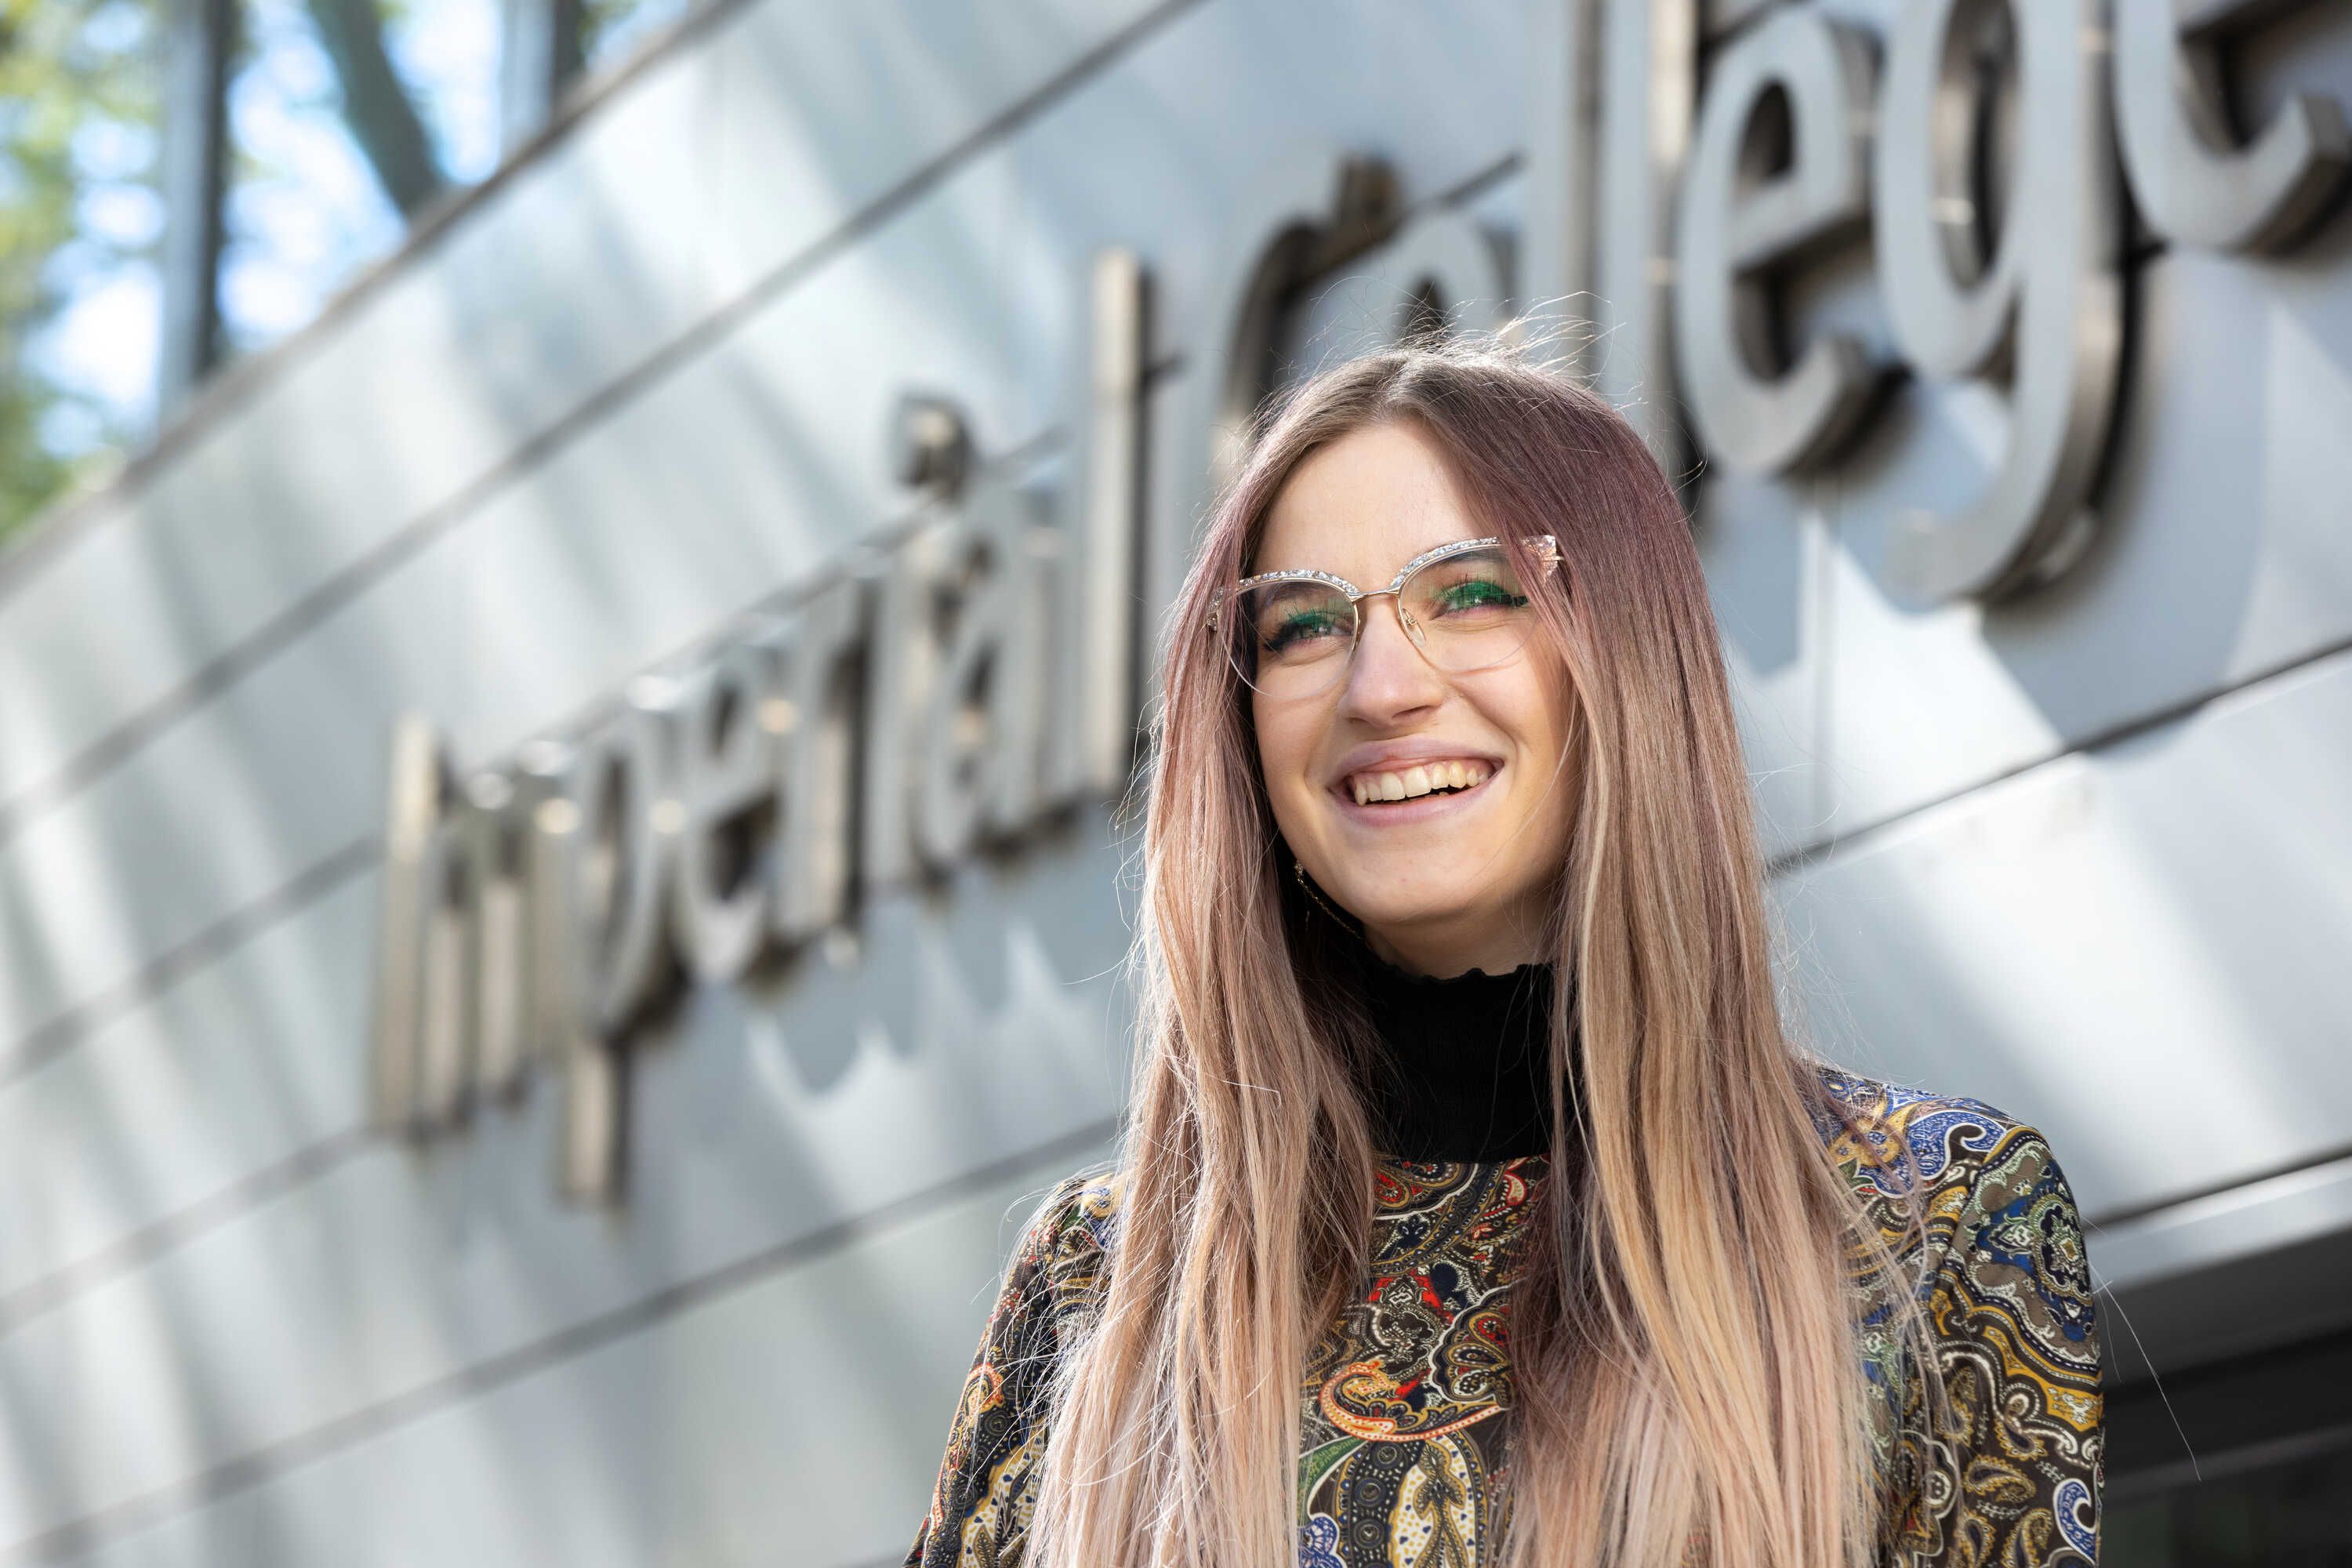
[{"xmin": 1237, "ymin": 421, "xmax": 1573, "ymax": 975}]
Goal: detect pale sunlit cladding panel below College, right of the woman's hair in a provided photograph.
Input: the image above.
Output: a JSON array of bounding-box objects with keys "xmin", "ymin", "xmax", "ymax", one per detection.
[{"xmin": 1778, "ymin": 654, "xmax": 2352, "ymax": 1232}]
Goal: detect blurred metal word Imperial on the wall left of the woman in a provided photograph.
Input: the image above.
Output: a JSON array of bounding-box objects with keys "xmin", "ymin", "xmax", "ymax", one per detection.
[{"xmin": 372, "ymin": 252, "xmax": 1143, "ymax": 1199}]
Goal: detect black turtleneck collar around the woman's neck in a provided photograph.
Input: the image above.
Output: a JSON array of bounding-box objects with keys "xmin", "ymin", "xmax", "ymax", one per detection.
[{"xmin": 1345, "ymin": 938, "xmax": 1552, "ymax": 1161}]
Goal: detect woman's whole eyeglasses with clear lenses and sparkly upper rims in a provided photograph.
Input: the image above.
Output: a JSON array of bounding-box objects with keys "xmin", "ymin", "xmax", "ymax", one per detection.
[{"xmin": 1209, "ymin": 534, "xmax": 1559, "ymax": 699}]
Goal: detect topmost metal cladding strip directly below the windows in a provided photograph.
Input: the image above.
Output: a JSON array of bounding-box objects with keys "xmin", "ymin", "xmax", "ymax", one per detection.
[{"xmin": 0, "ymin": 0, "xmax": 1181, "ymax": 801}]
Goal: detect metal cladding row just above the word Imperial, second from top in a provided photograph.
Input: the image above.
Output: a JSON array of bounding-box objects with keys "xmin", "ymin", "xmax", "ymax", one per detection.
[{"xmin": 0, "ymin": 7, "xmax": 1517, "ymax": 1072}]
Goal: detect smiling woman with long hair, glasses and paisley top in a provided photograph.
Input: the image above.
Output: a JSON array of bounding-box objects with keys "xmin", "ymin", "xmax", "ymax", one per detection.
[{"xmin": 908, "ymin": 341, "xmax": 2103, "ymax": 1568}]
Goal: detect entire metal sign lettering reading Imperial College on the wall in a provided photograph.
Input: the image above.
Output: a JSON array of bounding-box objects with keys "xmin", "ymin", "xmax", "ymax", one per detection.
[{"xmin": 372, "ymin": 0, "xmax": 2352, "ymax": 1199}]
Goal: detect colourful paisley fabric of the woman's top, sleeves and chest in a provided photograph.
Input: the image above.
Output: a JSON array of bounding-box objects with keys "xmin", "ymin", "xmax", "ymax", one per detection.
[{"xmin": 906, "ymin": 1069, "xmax": 2103, "ymax": 1568}]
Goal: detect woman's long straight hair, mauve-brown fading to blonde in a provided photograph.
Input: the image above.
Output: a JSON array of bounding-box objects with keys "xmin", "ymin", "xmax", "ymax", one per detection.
[{"xmin": 1028, "ymin": 336, "xmax": 1933, "ymax": 1568}]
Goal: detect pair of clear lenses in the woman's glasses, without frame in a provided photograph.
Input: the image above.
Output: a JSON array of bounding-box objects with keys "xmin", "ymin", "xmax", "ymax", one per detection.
[{"xmin": 1225, "ymin": 546, "xmax": 1536, "ymax": 699}]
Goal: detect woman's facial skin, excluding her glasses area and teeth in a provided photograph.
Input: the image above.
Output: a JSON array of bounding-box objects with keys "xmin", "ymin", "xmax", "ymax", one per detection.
[{"xmin": 1249, "ymin": 423, "xmax": 1576, "ymax": 975}]
